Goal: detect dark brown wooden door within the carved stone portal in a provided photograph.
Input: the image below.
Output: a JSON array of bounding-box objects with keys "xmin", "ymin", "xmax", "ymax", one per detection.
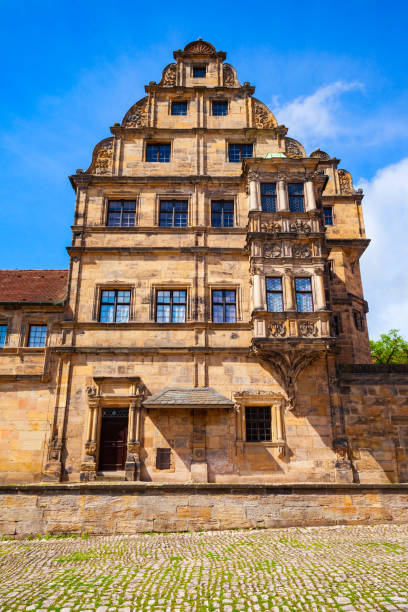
[{"xmin": 99, "ymin": 410, "xmax": 128, "ymax": 472}]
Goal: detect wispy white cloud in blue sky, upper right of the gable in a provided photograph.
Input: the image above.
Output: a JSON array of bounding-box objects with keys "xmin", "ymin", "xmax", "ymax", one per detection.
[{"xmin": 273, "ymin": 81, "xmax": 363, "ymax": 141}]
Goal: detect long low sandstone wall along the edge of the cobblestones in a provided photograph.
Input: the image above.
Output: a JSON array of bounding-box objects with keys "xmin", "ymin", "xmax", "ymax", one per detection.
[{"xmin": 0, "ymin": 483, "xmax": 408, "ymax": 537}]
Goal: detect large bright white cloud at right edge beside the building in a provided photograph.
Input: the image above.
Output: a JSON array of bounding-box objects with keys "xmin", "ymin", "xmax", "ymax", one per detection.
[{"xmin": 359, "ymin": 158, "xmax": 408, "ymax": 338}]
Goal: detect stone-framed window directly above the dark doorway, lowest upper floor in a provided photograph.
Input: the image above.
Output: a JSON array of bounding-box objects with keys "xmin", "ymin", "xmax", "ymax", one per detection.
[{"xmin": 92, "ymin": 281, "xmax": 135, "ymax": 324}]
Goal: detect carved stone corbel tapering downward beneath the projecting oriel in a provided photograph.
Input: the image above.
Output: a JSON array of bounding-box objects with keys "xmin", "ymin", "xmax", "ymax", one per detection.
[{"xmin": 251, "ymin": 343, "xmax": 321, "ymax": 411}]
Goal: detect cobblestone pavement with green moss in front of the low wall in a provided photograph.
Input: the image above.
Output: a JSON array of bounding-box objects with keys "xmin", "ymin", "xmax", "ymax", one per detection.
[{"xmin": 0, "ymin": 525, "xmax": 408, "ymax": 612}]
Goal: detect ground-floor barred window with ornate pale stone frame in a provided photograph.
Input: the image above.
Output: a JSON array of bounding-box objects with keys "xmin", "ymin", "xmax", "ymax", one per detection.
[{"xmin": 234, "ymin": 390, "xmax": 286, "ymax": 457}]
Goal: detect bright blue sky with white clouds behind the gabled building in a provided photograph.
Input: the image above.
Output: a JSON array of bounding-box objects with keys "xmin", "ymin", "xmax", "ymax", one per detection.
[{"xmin": 0, "ymin": 0, "xmax": 408, "ymax": 337}]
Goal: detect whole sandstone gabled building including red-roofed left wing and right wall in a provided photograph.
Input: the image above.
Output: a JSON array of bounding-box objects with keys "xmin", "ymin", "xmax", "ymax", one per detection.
[{"xmin": 0, "ymin": 40, "xmax": 408, "ymax": 483}]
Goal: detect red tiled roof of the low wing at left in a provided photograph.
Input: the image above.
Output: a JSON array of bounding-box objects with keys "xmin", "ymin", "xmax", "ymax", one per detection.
[{"xmin": 0, "ymin": 270, "xmax": 68, "ymax": 304}]
